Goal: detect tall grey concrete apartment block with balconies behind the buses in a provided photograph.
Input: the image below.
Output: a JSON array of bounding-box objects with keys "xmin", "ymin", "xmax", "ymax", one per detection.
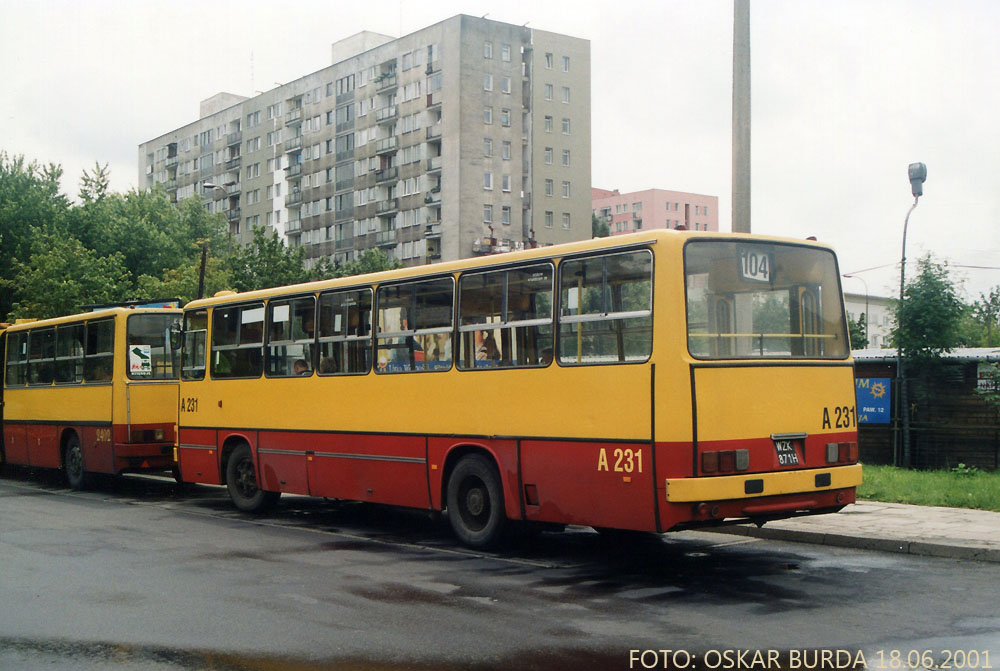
[{"xmin": 139, "ymin": 15, "xmax": 591, "ymax": 265}]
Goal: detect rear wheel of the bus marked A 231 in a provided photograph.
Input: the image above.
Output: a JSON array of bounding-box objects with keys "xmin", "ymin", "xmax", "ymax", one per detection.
[{"xmin": 448, "ymin": 454, "xmax": 507, "ymax": 549}]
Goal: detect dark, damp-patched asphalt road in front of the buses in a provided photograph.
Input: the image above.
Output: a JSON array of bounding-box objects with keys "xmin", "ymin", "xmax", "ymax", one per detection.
[{"xmin": 0, "ymin": 472, "xmax": 1000, "ymax": 671}]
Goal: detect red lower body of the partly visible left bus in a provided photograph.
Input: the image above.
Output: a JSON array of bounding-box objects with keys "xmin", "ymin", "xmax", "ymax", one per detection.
[{"xmin": 4, "ymin": 420, "xmax": 174, "ymax": 475}]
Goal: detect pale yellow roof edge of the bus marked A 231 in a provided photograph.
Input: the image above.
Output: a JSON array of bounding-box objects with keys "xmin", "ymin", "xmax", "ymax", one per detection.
[{"xmin": 184, "ymin": 229, "xmax": 832, "ymax": 310}]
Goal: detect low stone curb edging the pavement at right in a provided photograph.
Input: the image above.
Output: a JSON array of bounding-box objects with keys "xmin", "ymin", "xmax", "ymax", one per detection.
[{"xmin": 706, "ymin": 526, "xmax": 1000, "ymax": 563}]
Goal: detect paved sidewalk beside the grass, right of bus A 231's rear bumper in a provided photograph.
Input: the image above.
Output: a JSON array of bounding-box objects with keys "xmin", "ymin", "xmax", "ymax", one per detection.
[{"xmin": 714, "ymin": 501, "xmax": 1000, "ymax": 562}]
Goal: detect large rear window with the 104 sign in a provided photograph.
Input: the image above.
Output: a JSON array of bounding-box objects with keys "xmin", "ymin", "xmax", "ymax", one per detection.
[{"xmin": 684, "ymin": 240, "xmax": 850, "ymax": 359}]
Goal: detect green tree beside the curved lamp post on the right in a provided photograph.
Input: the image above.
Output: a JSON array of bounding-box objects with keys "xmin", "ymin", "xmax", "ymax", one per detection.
[{"xmin": 892, "ymin": 254, "xmax": 965, "ymax": 366}]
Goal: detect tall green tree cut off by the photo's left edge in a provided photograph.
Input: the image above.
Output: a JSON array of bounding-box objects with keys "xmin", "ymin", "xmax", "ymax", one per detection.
[{"xmin": 0, "ymin": 151, "xmax": 70, "ymax": 320}]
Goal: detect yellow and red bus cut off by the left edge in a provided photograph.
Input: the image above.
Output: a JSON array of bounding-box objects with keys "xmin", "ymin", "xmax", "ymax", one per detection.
[{"xmin": 0, "ymin": 308, "xmax": 181, "ymax": 489}]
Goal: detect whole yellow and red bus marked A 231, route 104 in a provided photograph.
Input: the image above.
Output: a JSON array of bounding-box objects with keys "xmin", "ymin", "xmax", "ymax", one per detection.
[{"xmin": 177, "ymin": 231, "xmax": 861, "ymax": 547}]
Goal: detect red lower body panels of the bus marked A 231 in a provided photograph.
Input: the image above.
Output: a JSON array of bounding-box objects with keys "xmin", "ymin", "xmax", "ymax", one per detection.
[{"xmin": 178, "ymin": 427, "xmax": 857, "ymax": 532}]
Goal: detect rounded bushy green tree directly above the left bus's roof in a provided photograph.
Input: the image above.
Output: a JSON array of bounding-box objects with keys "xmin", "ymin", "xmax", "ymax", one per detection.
[{"xmin": 5, "ymin": 231, "xmax": 131, "ymax": 319}]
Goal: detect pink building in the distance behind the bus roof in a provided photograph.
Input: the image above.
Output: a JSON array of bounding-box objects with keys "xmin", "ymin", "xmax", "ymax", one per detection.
[{"xmin": 590, "ymin": 188, "xmax": 719, "ymax": 235}]
